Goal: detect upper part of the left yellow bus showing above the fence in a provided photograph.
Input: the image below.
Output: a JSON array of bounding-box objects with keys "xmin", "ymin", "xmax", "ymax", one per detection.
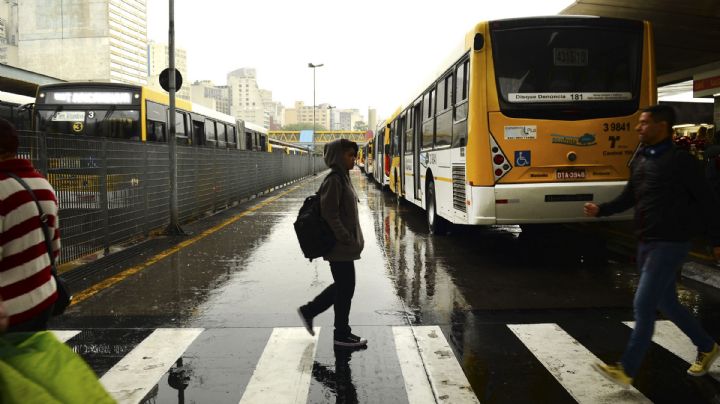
[{"xmin": 34, "ymin": 83, "xmax": 269, "ymax": 151}]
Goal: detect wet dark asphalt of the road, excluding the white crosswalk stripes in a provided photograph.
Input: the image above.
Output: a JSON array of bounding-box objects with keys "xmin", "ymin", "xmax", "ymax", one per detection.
[{"xmin": 51, "ymin": 170, "xmax": 720, "ymax": 403}]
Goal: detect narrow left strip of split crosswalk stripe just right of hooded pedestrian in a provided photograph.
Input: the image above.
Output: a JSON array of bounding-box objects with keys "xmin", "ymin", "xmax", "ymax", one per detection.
[{"xmin": 392, "ymin": 327, "xmax": 436, "ymax": 404}]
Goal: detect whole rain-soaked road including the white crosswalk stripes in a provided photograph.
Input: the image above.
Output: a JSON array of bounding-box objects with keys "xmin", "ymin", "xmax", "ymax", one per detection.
[{"xmin": 51, "ymin": 167, "xmax": 720, "ymax": 404}]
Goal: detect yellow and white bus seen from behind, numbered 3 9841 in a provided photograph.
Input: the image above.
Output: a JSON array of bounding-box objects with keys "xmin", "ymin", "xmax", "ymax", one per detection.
[{"xmin": 386, "ymin": 16, "xmax": 657, "ymax": 233}]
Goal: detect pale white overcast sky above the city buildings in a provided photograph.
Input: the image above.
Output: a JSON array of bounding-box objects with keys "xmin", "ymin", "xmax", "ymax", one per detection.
[{"xmin": 147, "ymin": 0, "xmax": 573, "ymax": 119}]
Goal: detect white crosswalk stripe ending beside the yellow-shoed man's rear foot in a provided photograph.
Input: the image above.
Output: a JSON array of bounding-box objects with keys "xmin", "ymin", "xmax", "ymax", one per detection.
[{"xmin": 508, "ymin": 324, "xmax": 650, "ymax": 404}]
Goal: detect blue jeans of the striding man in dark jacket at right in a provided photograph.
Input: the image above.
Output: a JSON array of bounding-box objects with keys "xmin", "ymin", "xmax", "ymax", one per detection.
[{"xmin": 622, "ymin": 241, "xmax": 715, "ymax": 377}]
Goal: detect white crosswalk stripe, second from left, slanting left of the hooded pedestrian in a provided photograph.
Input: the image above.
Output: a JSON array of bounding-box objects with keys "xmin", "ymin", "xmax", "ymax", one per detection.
[{"xmin": 100, "ymin": 328, "xmax": 203, "ymax": 403}]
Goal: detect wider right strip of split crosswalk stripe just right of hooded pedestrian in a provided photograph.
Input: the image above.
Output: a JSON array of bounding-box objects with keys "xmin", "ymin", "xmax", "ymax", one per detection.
[{"xmin": 403, "ymin": 326, "xmax": 480, "ymax": 404}]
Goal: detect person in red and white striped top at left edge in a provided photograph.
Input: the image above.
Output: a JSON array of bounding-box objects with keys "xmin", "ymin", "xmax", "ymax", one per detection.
[{"xmin": 0, "ymin": 119, "xmax": 60, "ymax": 332}]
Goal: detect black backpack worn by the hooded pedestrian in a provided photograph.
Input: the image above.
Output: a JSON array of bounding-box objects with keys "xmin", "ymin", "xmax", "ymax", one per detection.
[{"xmin": 293, "ymin": 172, "xmax": 342, "ymax": 261}]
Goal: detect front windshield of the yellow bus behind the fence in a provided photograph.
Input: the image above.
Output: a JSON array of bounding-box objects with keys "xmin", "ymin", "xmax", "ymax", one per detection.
[{"xmin": 36, "ymin": 105, "xmax": 140, "ymax": 140}]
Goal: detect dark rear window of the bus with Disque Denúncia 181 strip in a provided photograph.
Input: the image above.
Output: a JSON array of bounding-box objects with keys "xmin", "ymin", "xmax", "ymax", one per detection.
[{"xmin": 491, "ymin": 22, "xmax": 643, "ymax": 119}]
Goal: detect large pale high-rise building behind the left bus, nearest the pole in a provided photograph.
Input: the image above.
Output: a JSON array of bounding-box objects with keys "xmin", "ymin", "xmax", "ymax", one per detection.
[{"xmin": 16, "ymin": 0, "xmax": 148, "ymax": 84}]
